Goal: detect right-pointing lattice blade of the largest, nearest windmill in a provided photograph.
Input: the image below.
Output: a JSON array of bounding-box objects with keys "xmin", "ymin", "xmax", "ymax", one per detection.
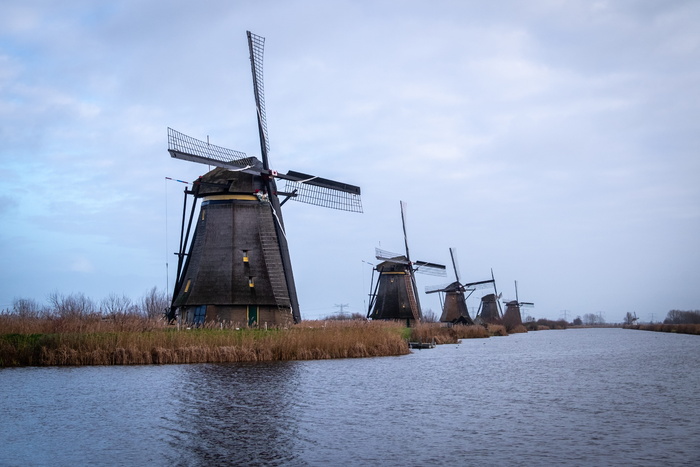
[{"xmin": 277, "ymin": 170, "xmax": 362, "ymax": 212}]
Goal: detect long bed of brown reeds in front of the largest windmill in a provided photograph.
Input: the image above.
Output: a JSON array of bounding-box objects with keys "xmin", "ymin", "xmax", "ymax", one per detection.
[{"xmin": 0, "ymin": 316, "xmax": 410, "ymax": 367}]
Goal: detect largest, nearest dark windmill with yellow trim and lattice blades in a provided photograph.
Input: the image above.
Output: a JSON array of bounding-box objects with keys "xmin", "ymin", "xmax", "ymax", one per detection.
[{"xmin": 168, "ymin": 31, "xmax": 362, "ymax": 325}]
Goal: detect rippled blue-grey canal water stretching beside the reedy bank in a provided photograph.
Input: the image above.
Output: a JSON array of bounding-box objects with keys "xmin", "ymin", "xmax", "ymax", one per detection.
[{"xmin": 0, "ymin": 329, "xmax": 700, "ymax": 466}]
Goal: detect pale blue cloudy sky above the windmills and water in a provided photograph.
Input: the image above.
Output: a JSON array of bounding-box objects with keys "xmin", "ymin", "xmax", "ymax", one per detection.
[{"xmin": 0, "ymin": 0, "xmax": 700, "ymax": 322}]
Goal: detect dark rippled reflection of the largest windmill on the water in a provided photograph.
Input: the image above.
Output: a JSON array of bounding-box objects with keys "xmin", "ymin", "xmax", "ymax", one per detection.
[{"xmin": 167, "ymin": 362, "xmax": 299, "ymax": 465}]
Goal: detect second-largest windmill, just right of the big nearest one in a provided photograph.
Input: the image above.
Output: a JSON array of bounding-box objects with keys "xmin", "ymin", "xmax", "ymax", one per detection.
[{"xmin": 367, "ymin": 201, "xmax": 445, "ymax": 326}]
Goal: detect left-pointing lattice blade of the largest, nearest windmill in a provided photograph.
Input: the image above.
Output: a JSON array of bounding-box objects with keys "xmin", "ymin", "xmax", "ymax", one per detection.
[{"xmin": 168, "ymin": 128, "xmax": 260, "ymax": 174}]
